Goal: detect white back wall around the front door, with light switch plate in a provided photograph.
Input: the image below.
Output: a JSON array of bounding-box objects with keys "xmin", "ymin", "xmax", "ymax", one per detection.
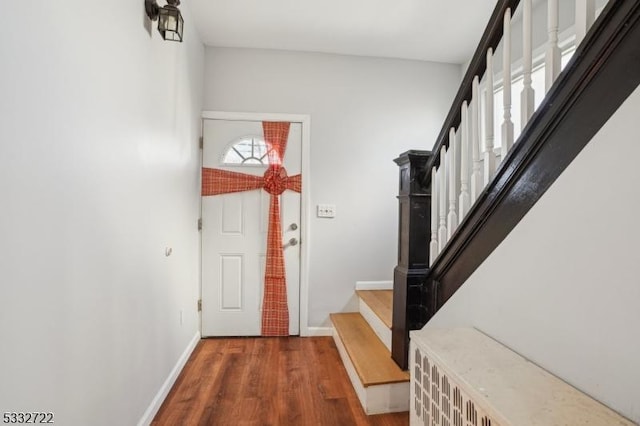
[{"xmin": 204, "ymin": 48, "xmax": 460, "ymax": 326}]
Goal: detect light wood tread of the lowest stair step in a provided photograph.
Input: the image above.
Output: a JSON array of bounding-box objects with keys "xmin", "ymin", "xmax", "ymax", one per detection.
[{"xmin": 331, "ymin": 312, "xmax": 409, "ymax": 387}]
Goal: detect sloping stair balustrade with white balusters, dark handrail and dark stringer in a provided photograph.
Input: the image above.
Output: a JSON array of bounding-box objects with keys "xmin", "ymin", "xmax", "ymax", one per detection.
[{"xmin": 392, "ymin": 0, "xmax": 640, "ymax": 365}]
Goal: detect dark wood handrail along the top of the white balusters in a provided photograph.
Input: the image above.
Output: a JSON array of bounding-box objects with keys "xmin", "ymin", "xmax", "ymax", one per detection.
[{"xmin": 425, "ymin": 0, "xmax": 520, "ymax": 173}]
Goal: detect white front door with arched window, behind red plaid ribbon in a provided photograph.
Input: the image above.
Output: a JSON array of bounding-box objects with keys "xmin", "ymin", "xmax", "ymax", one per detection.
[{"xmin": 202, "ymin": 119, "xmax": 302, "ymax": 336}]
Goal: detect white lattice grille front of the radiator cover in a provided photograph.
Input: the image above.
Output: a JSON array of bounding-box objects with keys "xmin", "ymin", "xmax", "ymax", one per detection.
[{"xmin": 410, "ymin": 348, "xmax": 500, "ymax": 426}]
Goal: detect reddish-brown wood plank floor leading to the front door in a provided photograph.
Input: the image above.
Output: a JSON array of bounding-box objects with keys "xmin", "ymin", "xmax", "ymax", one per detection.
[{"xmin": 152, "ymin": 337, "xmax": 409, "ymax": 426}]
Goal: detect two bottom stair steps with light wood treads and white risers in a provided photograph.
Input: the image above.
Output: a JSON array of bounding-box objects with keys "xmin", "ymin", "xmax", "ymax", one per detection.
[{"xmin": 331, "ymin": 290, "xmax": 409, "ymax": 415}]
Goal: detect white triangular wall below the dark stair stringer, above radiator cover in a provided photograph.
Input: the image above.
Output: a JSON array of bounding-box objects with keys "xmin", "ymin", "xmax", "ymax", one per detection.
[{"xmin": 428, "ymin": 88, "xmax": 640, "ymax": 422}]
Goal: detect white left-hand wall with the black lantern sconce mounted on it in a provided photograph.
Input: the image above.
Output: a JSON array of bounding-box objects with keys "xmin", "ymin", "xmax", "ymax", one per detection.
[{"xmin": 0, "ymin": 0, "xmax": 204, "ymax": 425}]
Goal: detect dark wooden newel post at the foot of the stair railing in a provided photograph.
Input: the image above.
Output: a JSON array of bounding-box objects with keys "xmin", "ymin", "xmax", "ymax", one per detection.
[{"xmin": 391, "ymin": 150, "xmax": 431, "ymax": 370}]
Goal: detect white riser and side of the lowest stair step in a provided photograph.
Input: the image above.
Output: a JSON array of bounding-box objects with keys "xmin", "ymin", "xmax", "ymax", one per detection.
[{"xmin": 333, "ymin": 328, "xmax": 409, "ymax": 415}]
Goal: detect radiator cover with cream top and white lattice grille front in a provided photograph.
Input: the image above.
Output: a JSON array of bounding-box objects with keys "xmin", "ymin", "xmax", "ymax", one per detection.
[{"xmin": 409, "ymin": 327, "xmax": 635, "ymax": 426}]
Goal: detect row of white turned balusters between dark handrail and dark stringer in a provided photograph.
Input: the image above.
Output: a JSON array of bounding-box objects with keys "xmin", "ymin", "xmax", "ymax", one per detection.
[{"xmin": 429, "ymin": 0, "xmax": 603, "ymax": 265}]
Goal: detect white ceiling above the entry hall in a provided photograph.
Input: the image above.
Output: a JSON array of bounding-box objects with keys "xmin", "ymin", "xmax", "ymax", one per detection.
[{"xmin": 190, "ymin": 0, "xmax": 496, "ymax": 64}]
